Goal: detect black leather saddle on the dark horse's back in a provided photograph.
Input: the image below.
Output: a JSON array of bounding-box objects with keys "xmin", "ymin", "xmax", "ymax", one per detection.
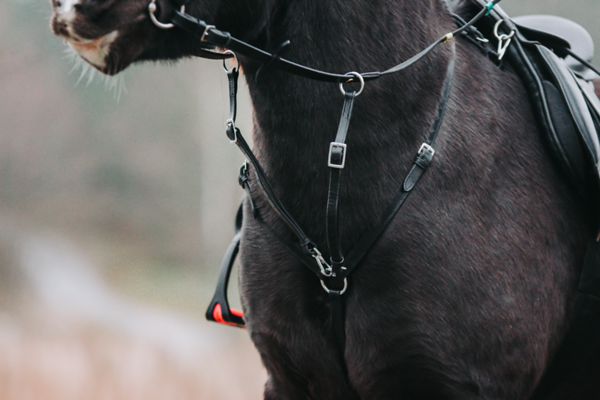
[{"xmin": 473, "ymin": 0, "xmax": 600, "ymax": 218}]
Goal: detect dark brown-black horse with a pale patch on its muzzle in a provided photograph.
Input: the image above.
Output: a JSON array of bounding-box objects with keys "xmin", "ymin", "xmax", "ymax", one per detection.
[{"xmin": 52, "ymin": 0, "xmax": 600, "ymax": 400}]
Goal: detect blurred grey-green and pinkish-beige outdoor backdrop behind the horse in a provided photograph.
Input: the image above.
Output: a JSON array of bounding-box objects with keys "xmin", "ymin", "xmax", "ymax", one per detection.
[{"xmin": 0, "ymin": 0, "xmax": 600, "ymax": 400}]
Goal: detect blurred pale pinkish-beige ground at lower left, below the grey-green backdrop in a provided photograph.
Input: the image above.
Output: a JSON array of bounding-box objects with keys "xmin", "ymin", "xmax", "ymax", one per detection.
[{"xmin": 0, "ymin": 233, "xmax": 265, "ymax": 400}]
